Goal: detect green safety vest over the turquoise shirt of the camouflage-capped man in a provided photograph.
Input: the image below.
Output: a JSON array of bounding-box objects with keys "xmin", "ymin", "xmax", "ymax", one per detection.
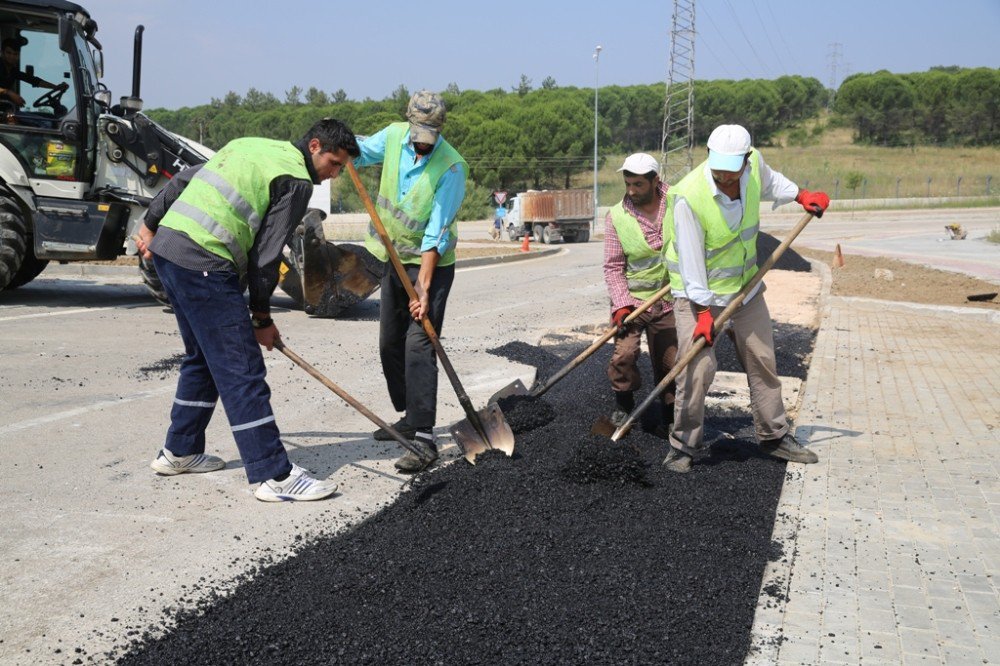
[{"xmin": 365, "ymin": 123, "xmax": 469, "ymax": 266}]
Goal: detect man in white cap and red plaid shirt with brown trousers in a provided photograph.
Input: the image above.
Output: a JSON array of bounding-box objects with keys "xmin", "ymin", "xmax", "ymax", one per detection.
[{"xmin": 604, "ymin": 153, "xmax": 677, "ymax": 438}]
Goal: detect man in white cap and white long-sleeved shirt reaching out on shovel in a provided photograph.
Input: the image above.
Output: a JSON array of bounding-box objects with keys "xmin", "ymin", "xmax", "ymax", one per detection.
[{"xmin": 663, "ymin": 125, "xmax": 830, "ymax": 472}]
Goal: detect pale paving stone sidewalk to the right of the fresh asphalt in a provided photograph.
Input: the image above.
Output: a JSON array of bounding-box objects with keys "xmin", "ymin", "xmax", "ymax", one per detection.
[{"xmin": 746, "ymin": 297, "xmax": 1000, "ymax": 666}]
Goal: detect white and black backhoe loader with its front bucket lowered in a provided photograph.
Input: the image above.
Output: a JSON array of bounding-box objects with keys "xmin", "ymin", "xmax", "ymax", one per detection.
[{"xmin": 0, "ymin": 0, "xmax": 380, "ymax": 316}]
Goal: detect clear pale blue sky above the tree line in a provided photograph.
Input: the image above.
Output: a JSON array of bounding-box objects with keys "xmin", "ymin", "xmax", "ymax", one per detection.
[{"xmin": 80, "ymin": 0, "xmax": 1000, "ymax": 108}]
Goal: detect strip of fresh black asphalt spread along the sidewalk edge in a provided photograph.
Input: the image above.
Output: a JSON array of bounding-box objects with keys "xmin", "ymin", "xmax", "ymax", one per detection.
[{"xmin": 106, "ymin": 292, "xmax": 820, "ymax": 665}]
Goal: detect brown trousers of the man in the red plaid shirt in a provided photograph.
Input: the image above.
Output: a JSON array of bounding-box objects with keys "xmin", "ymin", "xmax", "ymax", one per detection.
[{"xmin": 608, "ymin": 311, "xmax": 677, "ymax": 406}]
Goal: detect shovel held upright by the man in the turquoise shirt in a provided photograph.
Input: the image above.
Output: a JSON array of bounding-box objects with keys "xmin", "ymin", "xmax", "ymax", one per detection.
[{"xmin": 347, "ymin": 161, "xmax": 514, "ymax": 465}]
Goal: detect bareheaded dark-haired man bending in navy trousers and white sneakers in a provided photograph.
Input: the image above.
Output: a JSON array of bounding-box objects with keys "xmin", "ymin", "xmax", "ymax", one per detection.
[{"xmin": 136, "ymin": 118, "xmax": 358, "ymax": 502}]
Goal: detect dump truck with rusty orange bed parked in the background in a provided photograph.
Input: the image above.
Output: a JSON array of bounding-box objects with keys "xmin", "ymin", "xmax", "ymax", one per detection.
[{"xmin": 505, "ymin": 190, "xmax": 594, "ymax": 243}]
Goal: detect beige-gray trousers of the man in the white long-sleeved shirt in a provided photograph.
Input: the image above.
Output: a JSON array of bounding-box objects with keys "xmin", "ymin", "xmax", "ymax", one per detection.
[{"xmin": 670, "ymin": 288, "xmax": 788, "ymax": 454}]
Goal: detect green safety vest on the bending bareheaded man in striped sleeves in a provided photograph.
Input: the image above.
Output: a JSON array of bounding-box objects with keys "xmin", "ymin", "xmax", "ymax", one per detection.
[{"xmin": 160, "ymin": 138, "xmax": 312, "ymax": 276}]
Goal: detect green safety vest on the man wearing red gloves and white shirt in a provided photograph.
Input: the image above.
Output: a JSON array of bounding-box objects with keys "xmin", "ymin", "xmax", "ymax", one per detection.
[{"xmin": 663, "ymin": 149, "xmax": 760, "ymax": 300}]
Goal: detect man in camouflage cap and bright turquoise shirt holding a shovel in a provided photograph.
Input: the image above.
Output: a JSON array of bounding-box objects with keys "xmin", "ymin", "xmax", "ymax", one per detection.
[{"xmin": 354, "ymin": 90, "xmax": 469, "ymax": 473}]
